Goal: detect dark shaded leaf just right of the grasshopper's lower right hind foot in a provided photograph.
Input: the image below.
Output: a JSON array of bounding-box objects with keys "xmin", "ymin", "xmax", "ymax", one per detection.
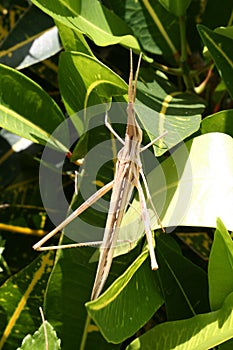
[{"xmin": 156, "ymin": 233, "xmax": 209, "ymax": 321}]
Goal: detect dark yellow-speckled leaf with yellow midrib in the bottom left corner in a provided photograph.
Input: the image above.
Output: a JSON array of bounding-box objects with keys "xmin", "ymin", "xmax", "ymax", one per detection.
[{"xmin": 0, "ymin": 252, "xmax": 54, "ymax": 349}]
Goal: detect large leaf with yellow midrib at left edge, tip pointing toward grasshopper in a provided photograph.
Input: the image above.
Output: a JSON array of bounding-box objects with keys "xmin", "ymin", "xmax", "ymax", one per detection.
[{"xmin": 0, "ymin": 65, "xmax": 68, "ymax": 152}]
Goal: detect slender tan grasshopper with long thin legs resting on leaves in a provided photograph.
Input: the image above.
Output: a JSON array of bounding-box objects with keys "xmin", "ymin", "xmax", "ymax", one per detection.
[{"xmin": 33, "ymin": 51, "xmax": 167, "ymax": 300}]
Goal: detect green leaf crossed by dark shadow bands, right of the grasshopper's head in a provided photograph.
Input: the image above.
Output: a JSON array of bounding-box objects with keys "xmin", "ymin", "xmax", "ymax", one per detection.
[{"xmin": 135, "ymin": 76, "xmax": 205, "ymax": 156}]
